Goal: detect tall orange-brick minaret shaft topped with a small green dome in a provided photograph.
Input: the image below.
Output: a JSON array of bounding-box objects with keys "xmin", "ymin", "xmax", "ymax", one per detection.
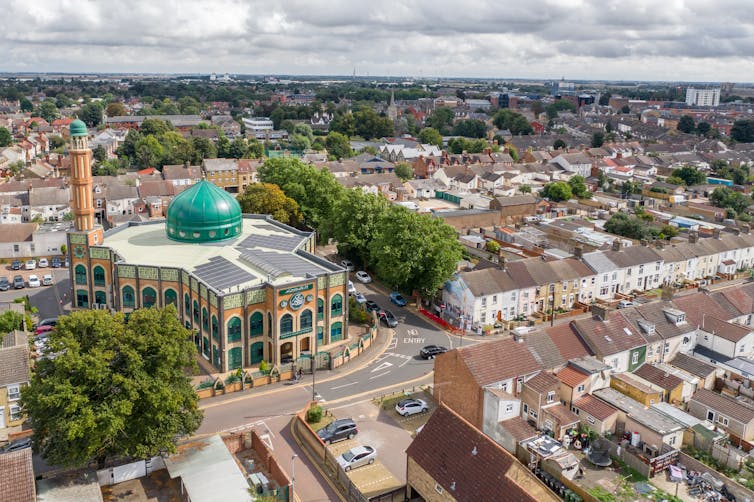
[{"xmin": 70, "ymin": 119, "xmax": 94, "ymax": 232}]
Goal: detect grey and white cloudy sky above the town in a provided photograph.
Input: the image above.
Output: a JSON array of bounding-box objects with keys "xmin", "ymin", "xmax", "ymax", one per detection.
[{"xmin": 0, "ymin": 0, "xmax": 754, "ymax": 82}]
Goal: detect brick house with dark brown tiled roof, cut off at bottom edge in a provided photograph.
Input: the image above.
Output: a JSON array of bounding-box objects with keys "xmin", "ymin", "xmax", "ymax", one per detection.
[{"xmin": 406, "ymin": 404, "xmax": 560, "ymax": 502}]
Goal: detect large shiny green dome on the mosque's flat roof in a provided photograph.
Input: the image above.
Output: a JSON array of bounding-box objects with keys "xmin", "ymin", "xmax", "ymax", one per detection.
[{"xmin": 167, "ymin": 180, "xmax": 241, "ymax": 242}]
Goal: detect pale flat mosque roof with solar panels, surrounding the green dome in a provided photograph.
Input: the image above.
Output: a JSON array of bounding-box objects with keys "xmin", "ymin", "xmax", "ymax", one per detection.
[{"xmin": 103, "ymin": 215, "xmax": 342, "ymax": 292}]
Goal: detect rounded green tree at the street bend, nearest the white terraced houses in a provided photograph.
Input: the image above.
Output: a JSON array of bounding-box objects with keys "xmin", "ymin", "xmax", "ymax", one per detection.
[{"xmin": 372, "ymin": 206, "xmax": 463, "ymax": 296}]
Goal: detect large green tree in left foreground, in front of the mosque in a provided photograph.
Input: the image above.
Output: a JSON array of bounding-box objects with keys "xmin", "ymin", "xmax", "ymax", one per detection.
[{"xmin": 21, "ymin": 305, "xmax": 202, "ymax": 466}]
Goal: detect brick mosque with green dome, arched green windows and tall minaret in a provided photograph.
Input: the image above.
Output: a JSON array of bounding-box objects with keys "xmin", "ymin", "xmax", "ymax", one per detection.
[{"xmin": 68, "ymin": 120, "xmax": 348, "ymax": 372}]
